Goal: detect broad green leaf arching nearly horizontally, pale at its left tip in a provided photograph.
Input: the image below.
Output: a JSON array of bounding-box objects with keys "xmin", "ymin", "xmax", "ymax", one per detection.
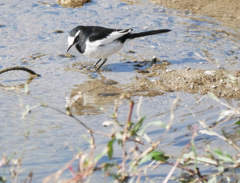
[{"xmin": 139, "ymin": 151, "xmax": 169, "ymax": 165}]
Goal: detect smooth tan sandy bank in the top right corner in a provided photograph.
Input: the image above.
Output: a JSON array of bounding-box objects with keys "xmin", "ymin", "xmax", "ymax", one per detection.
[{"xmin": 150, "ymin": 0, "xmax": 240, "ymax": 27}]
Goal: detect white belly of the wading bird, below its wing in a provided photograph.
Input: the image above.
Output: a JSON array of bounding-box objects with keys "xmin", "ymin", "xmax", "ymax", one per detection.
[{"xmin": 83, "ymin": 41, "xmax": 123, "ymax": 58}]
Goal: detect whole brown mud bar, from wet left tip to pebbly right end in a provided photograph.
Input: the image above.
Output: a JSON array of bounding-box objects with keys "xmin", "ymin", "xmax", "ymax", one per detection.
[{"xmin": 71, "ymin": 64, "xmax": 240, "ymax": 114}]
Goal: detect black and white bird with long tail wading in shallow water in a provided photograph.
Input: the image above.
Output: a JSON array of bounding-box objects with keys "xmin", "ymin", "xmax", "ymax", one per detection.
[{"xmin": 67, "ymin": 26, "xmax": 171, "ymax": 71}]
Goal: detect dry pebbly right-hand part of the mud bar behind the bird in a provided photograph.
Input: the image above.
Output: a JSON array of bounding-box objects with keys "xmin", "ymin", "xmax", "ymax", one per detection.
[{"xmin": 134, "ymin": 66, "xmax": 240, "ymax": 99}]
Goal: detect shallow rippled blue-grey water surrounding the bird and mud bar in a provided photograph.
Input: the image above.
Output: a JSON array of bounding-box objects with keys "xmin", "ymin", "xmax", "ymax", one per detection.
[{"xmin": 0, "ymin": 0, "xmax": 240, "ymax": 182}]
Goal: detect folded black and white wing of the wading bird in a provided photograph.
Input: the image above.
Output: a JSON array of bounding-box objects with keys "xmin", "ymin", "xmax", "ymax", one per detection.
[{"xmin": 89, "ymin": 28, "xmax": 132, "ymax": 45}]
